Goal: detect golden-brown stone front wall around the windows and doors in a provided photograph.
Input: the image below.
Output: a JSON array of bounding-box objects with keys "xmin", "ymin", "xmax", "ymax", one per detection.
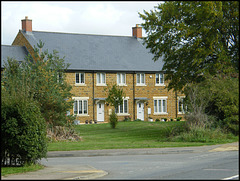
[{"xmin": 66, "ymin": 72, "xmax": 183, "ymax": 123}]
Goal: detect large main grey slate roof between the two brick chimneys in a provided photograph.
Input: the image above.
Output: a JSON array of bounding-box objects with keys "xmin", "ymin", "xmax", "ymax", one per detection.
[{"xmin": 20, "ymin": 30, "xmax": 163, "ymax": 72}]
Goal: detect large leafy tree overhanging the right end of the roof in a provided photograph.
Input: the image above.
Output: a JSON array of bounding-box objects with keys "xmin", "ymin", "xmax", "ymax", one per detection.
[{"xmin": 139, "ymin": 1, "xmax": 239, "ymax": 90}]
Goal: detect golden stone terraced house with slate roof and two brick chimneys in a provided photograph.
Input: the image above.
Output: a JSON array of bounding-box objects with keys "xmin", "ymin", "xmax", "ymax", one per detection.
[{"xmin": 2, "ymin": 17, "xmax": 184, "ymax": 123}]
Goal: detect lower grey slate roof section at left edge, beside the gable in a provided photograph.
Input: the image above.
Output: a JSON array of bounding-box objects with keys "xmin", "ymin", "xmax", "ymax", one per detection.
[{"xmin": 1, "ymin": 45, "xmax": 28, "ymax": 68}]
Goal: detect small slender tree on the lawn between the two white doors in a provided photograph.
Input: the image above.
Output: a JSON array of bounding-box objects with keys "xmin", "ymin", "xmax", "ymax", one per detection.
[{"xmin": 106, "ymin": 84, "xmax": 124, "ymax": 128}]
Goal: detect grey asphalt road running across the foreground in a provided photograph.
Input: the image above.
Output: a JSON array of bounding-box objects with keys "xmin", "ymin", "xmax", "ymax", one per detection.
[{"xmin": 42, "ymin": 151, "xmax": 239, "ymax": 180}]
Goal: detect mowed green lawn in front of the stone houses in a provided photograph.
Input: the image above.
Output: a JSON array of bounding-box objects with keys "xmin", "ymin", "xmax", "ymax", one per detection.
[{"xmin": 48, "ymin": 121, "xmax": 237, "ymax": 151}]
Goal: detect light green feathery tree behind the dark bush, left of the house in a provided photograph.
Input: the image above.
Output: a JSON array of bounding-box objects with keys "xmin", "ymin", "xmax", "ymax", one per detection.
[{"xmin": 3, "ymin": 41, "xmax": 74, "ymax": 126}]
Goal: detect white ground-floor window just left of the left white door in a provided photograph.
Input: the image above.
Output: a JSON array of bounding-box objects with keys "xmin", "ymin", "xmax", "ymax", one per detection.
[{"xmin": 73, "ymin": 97, "xmax": 88, "ymax": 115}]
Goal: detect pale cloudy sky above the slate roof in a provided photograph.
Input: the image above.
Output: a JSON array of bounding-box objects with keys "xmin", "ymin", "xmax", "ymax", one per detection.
[{"xmin": 1, "ymin": 1, "xmax": 163, "ymax": 45}]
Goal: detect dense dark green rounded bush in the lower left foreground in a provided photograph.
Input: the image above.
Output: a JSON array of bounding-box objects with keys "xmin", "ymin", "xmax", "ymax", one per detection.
[{"xmin": 1, "ymin": 94, "xmax": 47, "ymax": 166}]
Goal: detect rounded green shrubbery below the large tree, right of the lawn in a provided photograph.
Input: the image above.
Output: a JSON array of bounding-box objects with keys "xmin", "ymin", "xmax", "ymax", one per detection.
[{"xmin": 185, "ymin": 75, "xmax": 239, "ymax": 135}]
